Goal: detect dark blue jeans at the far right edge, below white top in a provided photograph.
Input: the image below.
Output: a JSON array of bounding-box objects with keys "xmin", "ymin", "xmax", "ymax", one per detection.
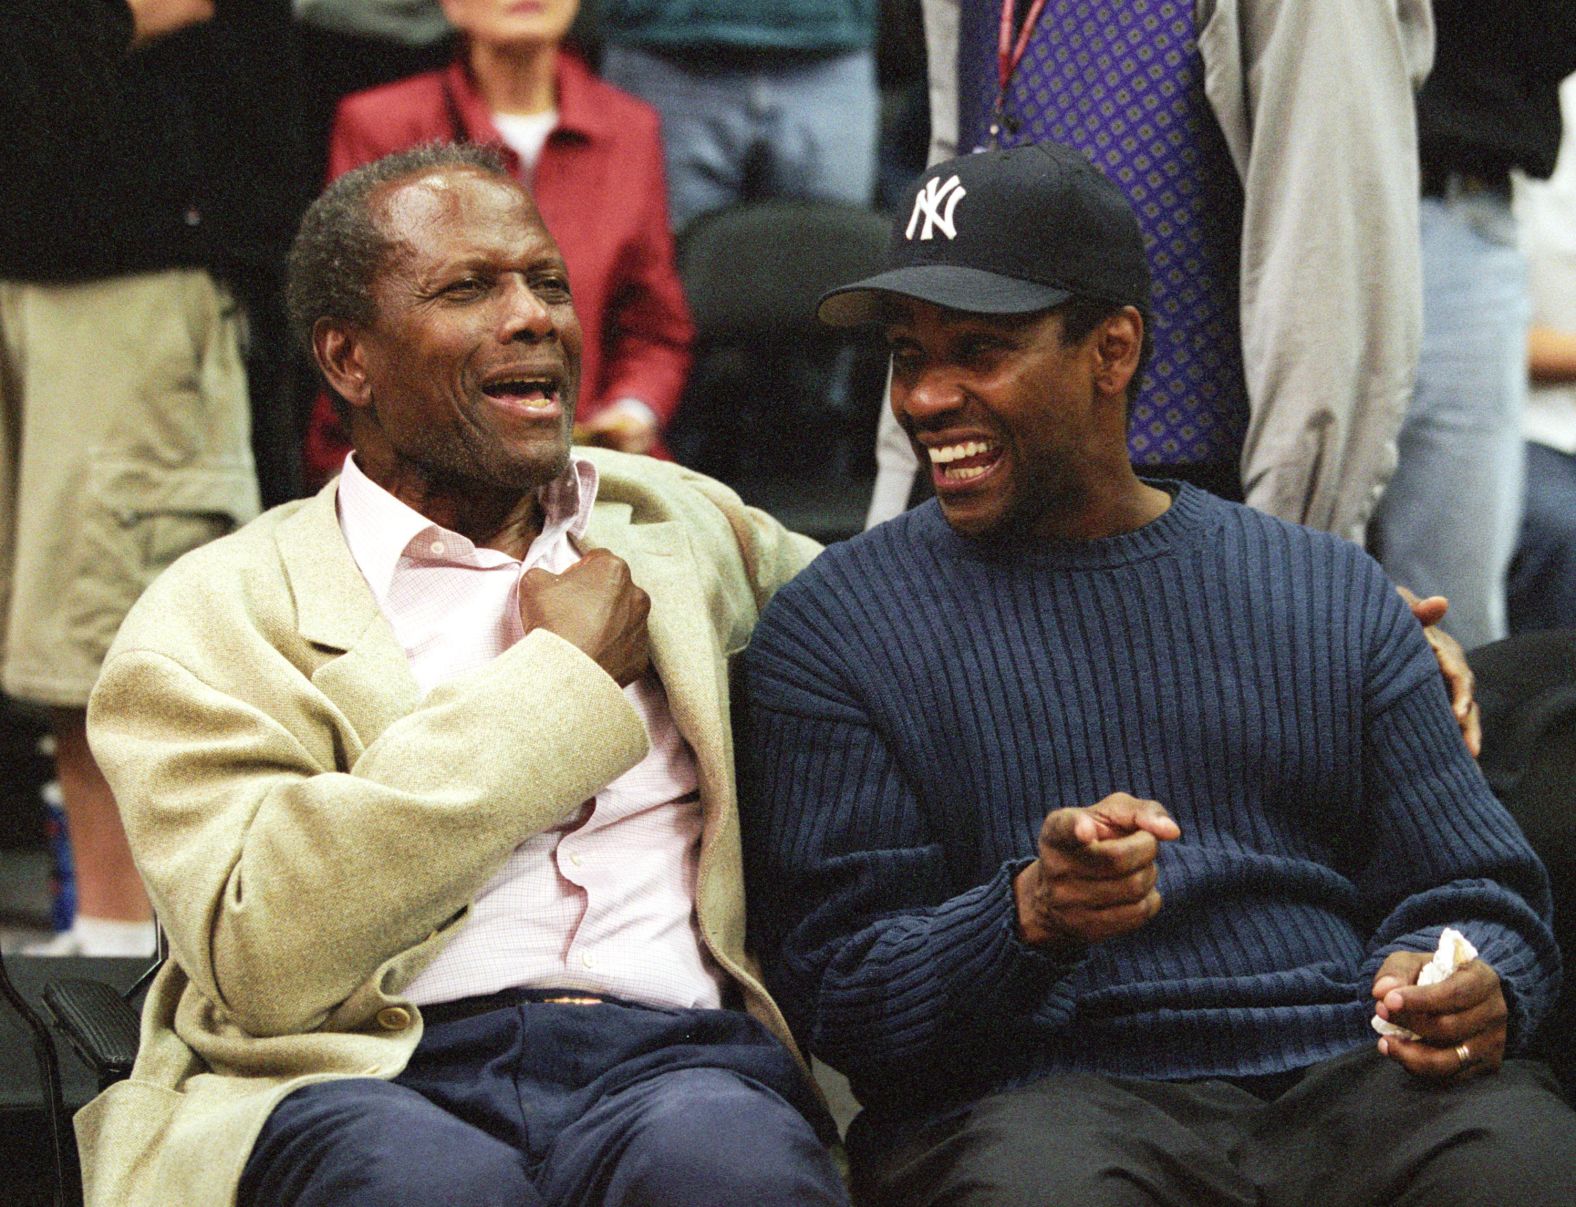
[{"xmin": 1510, "ymin": 443, "xmax": 1576, "ymax": 633}]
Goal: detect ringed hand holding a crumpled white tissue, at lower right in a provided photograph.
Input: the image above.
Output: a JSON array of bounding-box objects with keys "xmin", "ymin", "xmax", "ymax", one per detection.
[{"xmin": 1373, "ymin": 952, "xmax": 1508, "ymax": 1081}]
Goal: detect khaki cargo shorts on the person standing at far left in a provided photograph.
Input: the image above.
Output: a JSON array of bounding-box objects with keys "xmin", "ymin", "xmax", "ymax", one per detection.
[{"xmin": 0, "ymin": 269, "xmax": 258, "ymax": 707}]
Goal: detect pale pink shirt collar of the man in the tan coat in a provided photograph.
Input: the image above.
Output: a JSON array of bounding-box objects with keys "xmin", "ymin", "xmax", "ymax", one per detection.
[{"xmin": 337, "ymin": 454, "xmax": 597, "ymax": 605}]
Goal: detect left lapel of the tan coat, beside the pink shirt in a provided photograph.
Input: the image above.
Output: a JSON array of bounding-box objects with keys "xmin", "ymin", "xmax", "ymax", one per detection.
[{"xmin": 276, "ymin": 482, "xmax": 421, "ymax": 756}]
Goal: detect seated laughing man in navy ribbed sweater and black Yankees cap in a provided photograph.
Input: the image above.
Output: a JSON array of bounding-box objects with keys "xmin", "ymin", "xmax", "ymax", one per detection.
[{"xmin": 741, "ymin": 143, "xmax": 1576, "ymax": 1207}]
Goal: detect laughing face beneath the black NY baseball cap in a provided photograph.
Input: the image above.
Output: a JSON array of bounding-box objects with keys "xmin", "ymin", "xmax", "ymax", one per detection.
[{"xmin": 887, "ymin": 296, "xmax": 1143, "ymax": 539}]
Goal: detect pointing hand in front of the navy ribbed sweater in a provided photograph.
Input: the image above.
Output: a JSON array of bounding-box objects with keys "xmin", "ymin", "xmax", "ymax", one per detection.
[{"xmin": 1012, "ymin": 793, "xmax": 1182, "ymax": 947}]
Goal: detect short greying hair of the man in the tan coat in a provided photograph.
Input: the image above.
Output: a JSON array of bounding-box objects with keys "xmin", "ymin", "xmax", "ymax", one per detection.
[{"xmin": 285, "ymin": 142, "xmax": 514, "ymax": 362}]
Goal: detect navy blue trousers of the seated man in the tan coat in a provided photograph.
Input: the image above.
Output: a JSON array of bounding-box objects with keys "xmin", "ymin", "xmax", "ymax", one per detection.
[{"xmin": 238, "ymin": 991, "xmax": 848, "ymax": 1207}]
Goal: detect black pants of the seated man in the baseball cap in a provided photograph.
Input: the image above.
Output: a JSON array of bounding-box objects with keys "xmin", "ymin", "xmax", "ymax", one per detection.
[{"xmin": 851, "ymin": 1048, "xmax": 1576, "ymax": 1207}]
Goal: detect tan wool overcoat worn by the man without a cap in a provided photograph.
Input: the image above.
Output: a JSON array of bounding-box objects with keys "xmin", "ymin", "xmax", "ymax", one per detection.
[{"xmin": 77, "ymin": 452, "xmax": 816, "ymax": 1207}]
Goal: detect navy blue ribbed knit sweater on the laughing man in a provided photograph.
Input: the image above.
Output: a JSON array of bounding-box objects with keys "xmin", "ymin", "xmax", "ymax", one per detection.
[{"xmin": 739, "ymin": 487, "xmax": 1559, "ymax": 1125}]
